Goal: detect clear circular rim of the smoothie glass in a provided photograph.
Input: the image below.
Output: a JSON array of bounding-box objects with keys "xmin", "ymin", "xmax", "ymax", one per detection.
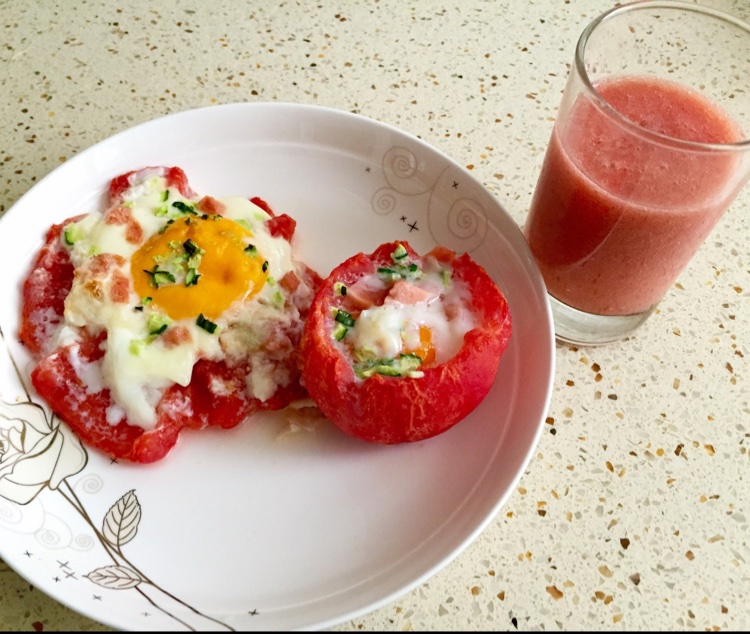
[{"xmin": 574, "ymin": 0, "xmax": 750, "ymax": 153}]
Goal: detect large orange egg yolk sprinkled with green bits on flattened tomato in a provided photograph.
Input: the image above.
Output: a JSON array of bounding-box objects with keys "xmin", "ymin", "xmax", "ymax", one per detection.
[{"xmin": 130, "ymin": 216, "xmax": 268, "ymax": 320}]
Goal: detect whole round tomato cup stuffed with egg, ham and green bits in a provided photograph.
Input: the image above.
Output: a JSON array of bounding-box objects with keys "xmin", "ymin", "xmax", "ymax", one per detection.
[{"xmin": 301, "ymin": 242, "xmax": 511, "ymax": 444}]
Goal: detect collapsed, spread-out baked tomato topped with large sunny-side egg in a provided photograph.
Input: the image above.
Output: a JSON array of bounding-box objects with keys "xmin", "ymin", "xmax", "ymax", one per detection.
[{"xmin": 19, "ymin": 166, "xmax": 320, "ymax": 463}]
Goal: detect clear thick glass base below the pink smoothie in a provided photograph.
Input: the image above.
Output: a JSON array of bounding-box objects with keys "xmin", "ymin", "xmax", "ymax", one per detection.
[{"xmin": 548, "ymin": 295, "xmax": 654, "ymax": 346}]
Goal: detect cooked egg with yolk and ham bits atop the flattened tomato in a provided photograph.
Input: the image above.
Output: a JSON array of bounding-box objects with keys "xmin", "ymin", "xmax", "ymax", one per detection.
[{"xmin": 57, "ymin": 169, "xmax": 298, "ymax": 429}]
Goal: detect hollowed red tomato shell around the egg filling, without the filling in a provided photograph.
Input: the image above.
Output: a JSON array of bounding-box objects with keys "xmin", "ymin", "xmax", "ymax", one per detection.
[{"xmin": 301, "ymin": 242, "xmax": 511, "ymax": 444}]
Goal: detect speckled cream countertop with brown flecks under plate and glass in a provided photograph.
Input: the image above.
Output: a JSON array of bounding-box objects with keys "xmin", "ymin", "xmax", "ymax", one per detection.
[{"xmin": 0, "ymin": 0, "xmax": 750, "ymax": 631}]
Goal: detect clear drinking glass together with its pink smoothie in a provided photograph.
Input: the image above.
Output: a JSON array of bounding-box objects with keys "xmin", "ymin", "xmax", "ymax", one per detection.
[{"xmin": 524, "ymin": 1, "xmax": 750, "ymax": 345}]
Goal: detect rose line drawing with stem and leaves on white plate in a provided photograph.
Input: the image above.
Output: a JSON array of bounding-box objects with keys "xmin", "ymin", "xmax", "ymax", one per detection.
[{"xmin": 0, "ymin": 327, "xmax": 235, "ymax": 631}]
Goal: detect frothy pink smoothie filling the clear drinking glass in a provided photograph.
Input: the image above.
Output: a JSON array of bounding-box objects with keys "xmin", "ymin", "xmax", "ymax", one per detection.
[{"xmin": 524, "ymin": 77, "xmax": 743, "ymax": 315}]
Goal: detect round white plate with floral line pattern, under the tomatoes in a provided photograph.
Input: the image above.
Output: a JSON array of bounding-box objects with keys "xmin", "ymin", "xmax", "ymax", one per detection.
[{"xmin": 0, "ymin": 104, "xmax": 554, "ymax": 630}]
